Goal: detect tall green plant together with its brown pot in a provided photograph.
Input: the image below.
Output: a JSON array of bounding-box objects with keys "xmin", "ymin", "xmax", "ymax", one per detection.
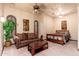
[{"xmin": 3, "ymin": 20, "xmax": 15, "ymax": 47}]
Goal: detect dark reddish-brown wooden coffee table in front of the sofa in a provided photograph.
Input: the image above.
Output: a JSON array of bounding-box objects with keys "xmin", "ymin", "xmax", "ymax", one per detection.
[{"xmin": 28, "ymin": 41, "xmax": 48, "ymax": 56}]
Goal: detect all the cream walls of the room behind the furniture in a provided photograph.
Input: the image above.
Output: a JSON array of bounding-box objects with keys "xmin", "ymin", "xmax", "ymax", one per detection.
[{"xmin": 0, "ymin": 4, "xmax": 77, "ymax": 51}]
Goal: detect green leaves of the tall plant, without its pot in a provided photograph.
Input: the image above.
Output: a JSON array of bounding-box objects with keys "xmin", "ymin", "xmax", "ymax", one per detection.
[{"xmin": 3, "ymin": 20, "xmax": 16, "ymax": 41}]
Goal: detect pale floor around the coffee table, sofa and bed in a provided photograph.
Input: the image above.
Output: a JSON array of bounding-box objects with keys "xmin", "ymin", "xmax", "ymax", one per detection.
[{"xmin": 2, "ymin": 41, "xmax": 79, "ymax": 56}]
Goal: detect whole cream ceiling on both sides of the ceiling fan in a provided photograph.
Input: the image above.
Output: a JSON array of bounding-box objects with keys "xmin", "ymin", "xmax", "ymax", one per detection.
[{"xmin": 0, "ymin": 3, "xmax": 77, "ymax": 17}]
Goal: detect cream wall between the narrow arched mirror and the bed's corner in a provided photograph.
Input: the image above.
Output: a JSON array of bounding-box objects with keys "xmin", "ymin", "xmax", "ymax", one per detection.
[{"xmin": 38, "ymin": 14, "xmax": 55, "ymax": 39}]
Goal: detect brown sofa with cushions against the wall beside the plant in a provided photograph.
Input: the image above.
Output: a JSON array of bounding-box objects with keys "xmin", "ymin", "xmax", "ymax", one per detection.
[{"xmin": 14, "ymin": 33, "xmax": 39, "ymax": 49}]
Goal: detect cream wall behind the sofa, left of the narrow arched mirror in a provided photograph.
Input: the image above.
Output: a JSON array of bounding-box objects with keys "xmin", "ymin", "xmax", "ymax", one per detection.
[{"xmin": 4, "ymin": 7, "xmax": 34, "ymax": 33}]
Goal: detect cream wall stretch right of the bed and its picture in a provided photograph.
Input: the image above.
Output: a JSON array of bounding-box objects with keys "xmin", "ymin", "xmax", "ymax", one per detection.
[{"xmin": 67, "ymin": 13, "xmax": 78, "ymax": 40}]
